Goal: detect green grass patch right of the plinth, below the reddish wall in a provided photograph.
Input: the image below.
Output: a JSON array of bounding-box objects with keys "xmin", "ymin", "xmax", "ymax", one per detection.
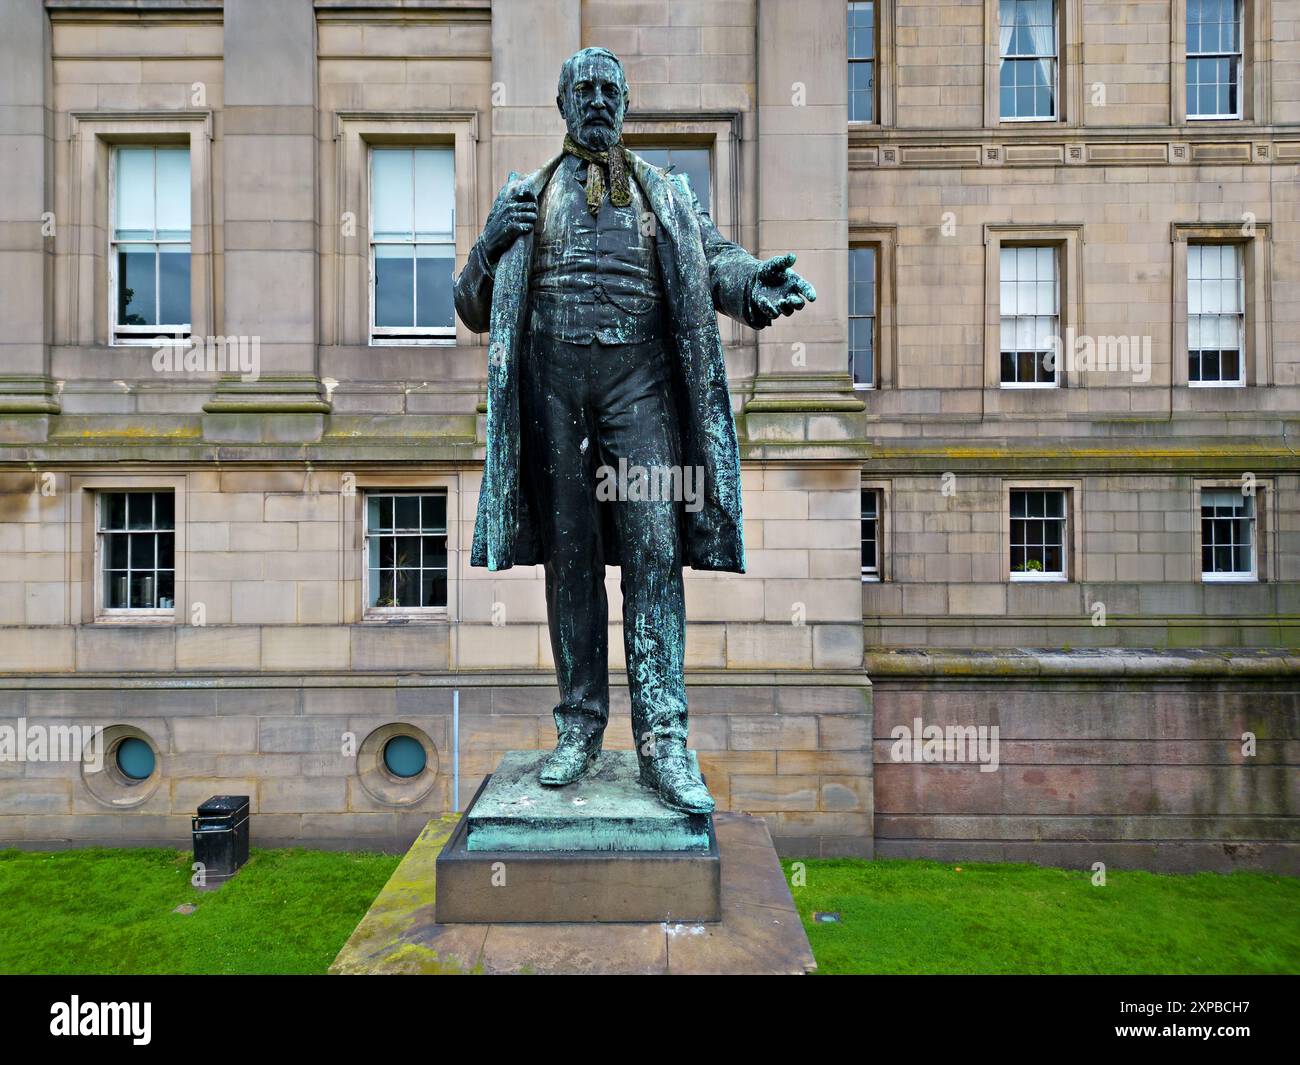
[{"xmin": 783, "ymin": 860, "xmax": 1300, "ymax": 974}]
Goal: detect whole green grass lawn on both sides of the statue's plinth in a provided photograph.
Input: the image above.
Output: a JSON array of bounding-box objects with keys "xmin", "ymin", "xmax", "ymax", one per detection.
[{"xmin": 0, "ymin": 849, "xmax": 1300, "ymax": 974}]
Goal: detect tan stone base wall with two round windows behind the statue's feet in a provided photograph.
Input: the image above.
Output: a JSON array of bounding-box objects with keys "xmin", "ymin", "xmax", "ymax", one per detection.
[{"xmin": 0, "ymin": 676, "xmax": 872, "ymax": 857}]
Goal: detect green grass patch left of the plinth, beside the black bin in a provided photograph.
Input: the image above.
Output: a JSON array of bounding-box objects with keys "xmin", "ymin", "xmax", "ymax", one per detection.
[{"xmin": 0, "ymin": 849, "xmax": 400, "ymax": 974}]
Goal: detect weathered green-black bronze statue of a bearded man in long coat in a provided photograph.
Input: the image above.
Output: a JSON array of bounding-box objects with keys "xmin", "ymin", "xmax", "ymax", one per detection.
[{"xmin": 456, "ymin": 48, "xmax": 816, "ymax": 813}]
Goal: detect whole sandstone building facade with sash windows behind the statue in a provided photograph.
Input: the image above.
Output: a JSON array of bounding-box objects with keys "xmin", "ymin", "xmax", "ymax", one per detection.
[{"xmin": 0, "ymin": 0, "xmax": 1300, "ymax": 871}]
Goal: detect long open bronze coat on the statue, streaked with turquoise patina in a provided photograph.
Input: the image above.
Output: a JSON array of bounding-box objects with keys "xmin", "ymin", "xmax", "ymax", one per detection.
[{"xmin": 455, "ymin": 153, "xmax": 759, "ymax": 573}]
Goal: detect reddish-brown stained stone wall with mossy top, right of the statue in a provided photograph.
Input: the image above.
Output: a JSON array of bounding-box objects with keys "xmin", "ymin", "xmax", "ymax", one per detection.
[{"xmin": 868, "ymin": 653, "xmax": 1300, "ymax": 875}]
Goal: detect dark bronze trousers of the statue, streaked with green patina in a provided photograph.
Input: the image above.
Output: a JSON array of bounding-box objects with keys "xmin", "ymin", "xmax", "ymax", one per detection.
[{"xmin": 520, "ymin": 332, "xmax": 686, "ymax": 761}]
